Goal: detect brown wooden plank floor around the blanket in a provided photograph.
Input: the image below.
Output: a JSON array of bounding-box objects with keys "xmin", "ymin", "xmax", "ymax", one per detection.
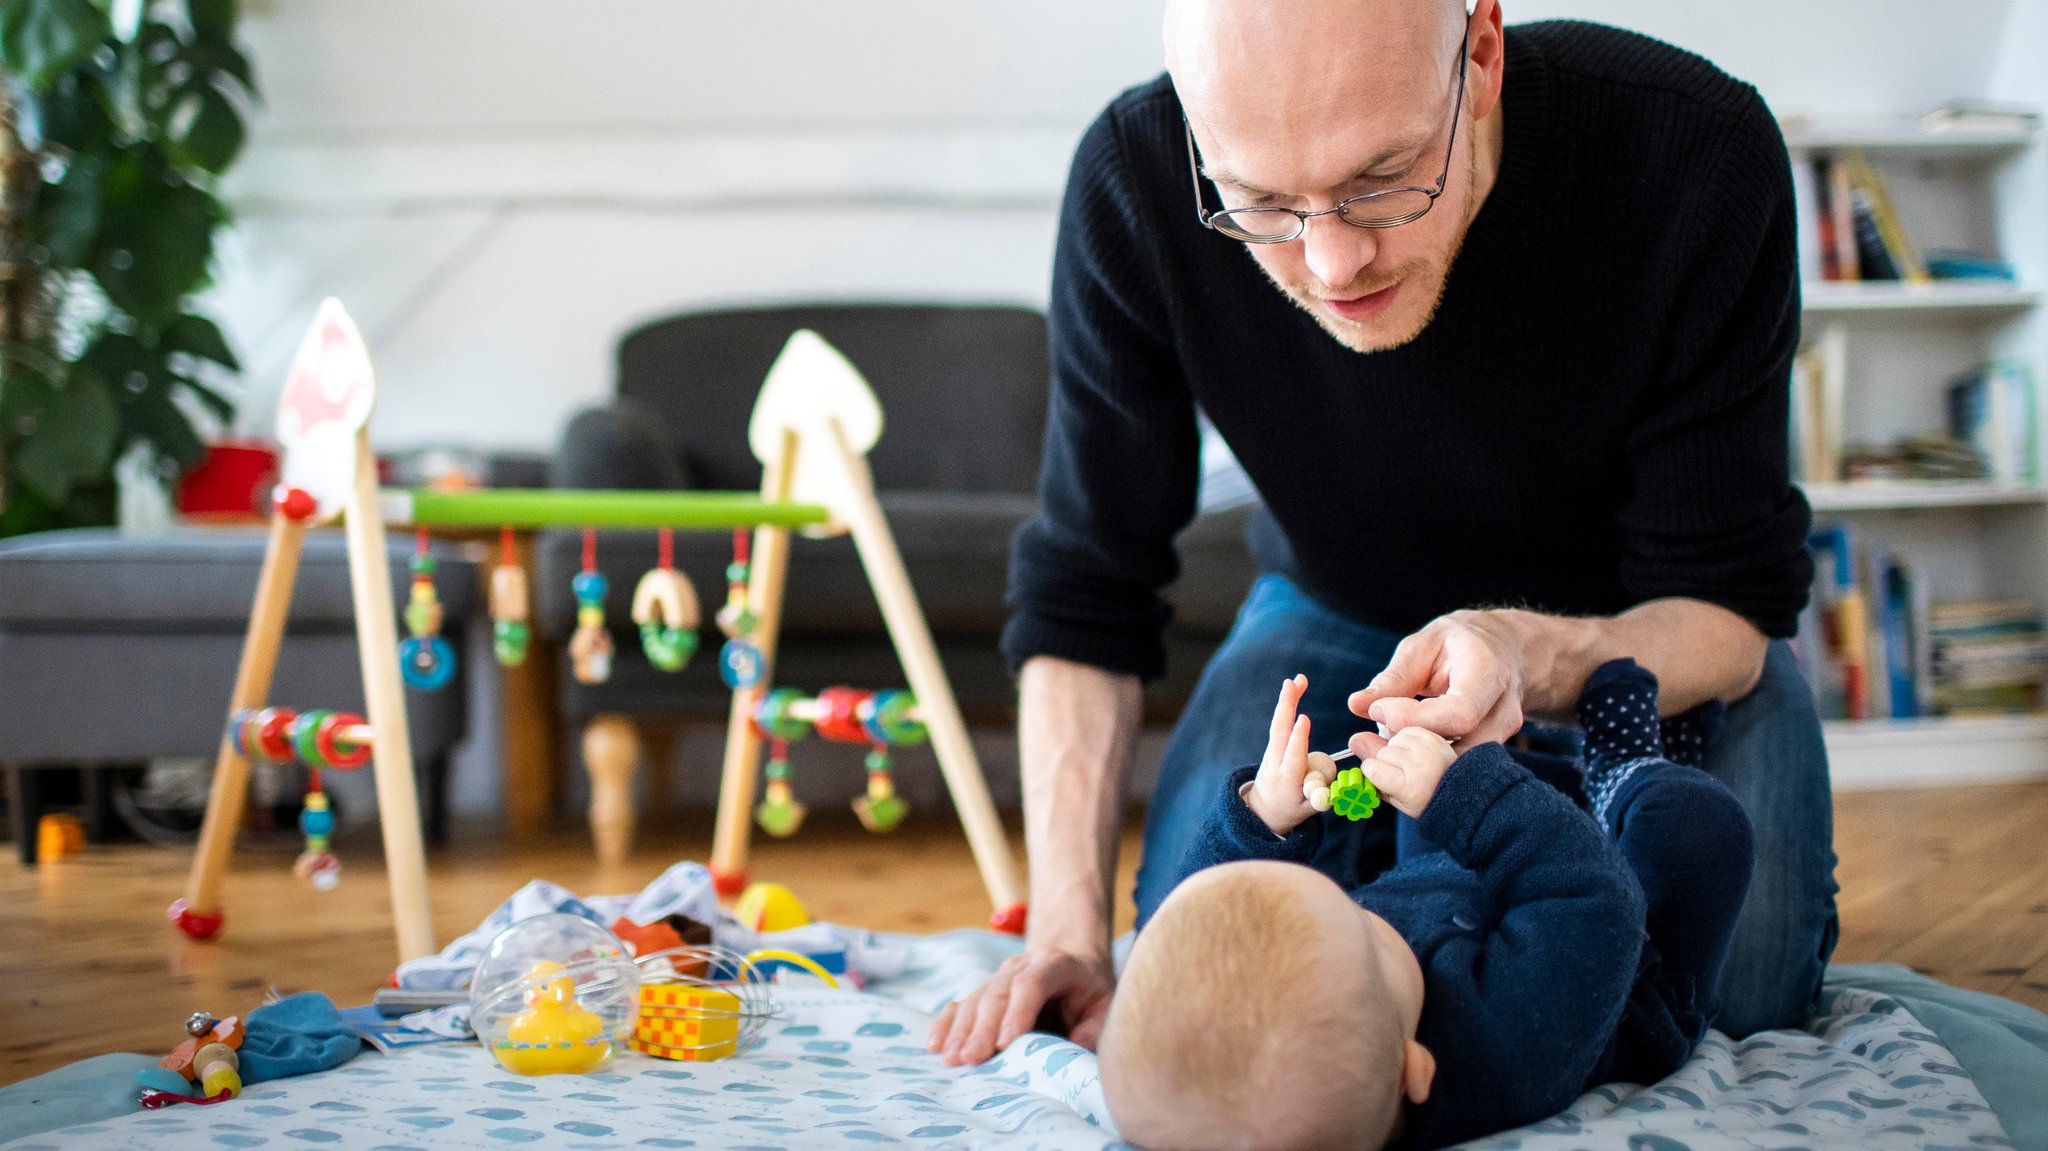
[{"xmin": 0, "ymin": 782, "xmax": 2048, "ymax": 1083}]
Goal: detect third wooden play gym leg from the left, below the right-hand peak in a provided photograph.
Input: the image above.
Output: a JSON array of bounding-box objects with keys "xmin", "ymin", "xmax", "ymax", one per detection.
[{"xmin": 711, "ymin": 430, "xmax": 797, "ymax": 895}]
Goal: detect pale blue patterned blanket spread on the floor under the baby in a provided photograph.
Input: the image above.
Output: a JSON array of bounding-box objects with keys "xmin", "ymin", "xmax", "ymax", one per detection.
[{"xmin": 0, "ymin": 932, "xmax": 2048, "ymax": 1151}]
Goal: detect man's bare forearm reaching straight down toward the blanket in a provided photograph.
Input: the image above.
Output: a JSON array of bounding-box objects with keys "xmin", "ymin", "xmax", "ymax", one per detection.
[{"xmin": 1018, "ymin": 655, "xmax": 1139, "ymax": 958}]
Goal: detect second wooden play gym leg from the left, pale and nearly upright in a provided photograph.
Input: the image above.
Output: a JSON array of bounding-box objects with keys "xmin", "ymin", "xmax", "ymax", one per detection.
[{"xmin": 344, "ymin": 430, "xmax": 434, "ymax": 963}]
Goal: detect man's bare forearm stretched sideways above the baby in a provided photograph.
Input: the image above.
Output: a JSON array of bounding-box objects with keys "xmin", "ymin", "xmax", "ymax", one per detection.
[{"xmin": 1489, "ymin": 598, "xmax": 1769, "ymax": 717}]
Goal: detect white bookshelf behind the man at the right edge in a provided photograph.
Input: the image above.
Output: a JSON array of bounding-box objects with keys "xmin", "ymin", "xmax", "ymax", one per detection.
[{"xmin": 1786, "ymin": 121, "xmax": 2048, "ymax": 788}]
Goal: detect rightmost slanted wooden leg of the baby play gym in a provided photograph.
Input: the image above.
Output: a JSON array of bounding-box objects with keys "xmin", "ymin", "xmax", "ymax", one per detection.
[{"xmin": 829, "ymin": 422, "xmax": 1024, "ymax": 932}]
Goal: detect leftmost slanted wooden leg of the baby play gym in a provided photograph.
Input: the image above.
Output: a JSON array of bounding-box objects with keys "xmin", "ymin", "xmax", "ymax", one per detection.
[{"xmin": 170, "ymin": 512, "xmax": 305, "ymax": 938}]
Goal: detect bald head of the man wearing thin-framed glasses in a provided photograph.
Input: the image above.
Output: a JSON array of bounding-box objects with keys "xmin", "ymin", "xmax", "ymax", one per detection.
[{"xmin": 1165, "ymin": 0, "xmax": 1503, "ymax": 352}]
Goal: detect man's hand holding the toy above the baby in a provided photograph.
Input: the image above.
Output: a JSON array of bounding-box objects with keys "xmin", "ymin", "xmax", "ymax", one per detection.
[{"xmin": 1350, "ymin": 610, "xmax": 1524, "ymax": 745}]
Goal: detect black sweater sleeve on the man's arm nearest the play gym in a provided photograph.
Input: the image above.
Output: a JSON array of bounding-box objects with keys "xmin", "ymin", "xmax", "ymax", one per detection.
[{"xmin": 1004, "ymin": 104, "xmax": 1200, "ymax": 680}]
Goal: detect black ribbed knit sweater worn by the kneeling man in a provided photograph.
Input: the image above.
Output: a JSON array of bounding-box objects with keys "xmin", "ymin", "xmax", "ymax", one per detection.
[{"xmin": 1004, "ymin": 23, "xmax": 1810, "ymax": 678}]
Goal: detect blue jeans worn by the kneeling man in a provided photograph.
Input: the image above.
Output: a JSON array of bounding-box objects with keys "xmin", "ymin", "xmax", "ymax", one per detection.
[{"xmin": 1137, "ymin": 576, "xmax": 1837, "ymax": 1036}]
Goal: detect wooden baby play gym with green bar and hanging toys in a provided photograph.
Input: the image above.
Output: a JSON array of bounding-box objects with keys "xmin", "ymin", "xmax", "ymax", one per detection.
[{"xmin": 170, "ymin": 299, "xmax": 1024, "ymax": 961}]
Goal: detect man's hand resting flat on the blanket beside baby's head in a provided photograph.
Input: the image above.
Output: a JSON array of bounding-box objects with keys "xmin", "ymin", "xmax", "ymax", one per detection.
[{"xmin": 926, "ymin": 950, "xmax": 1116, "ymax": 1067}]
